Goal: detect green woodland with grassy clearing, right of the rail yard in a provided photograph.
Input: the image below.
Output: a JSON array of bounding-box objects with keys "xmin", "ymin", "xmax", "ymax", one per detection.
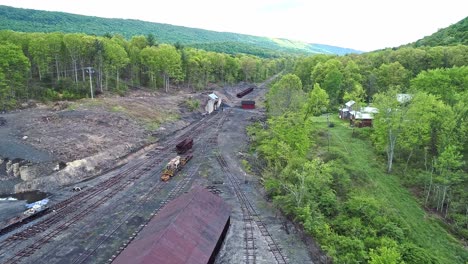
[{"xmin": 249, "ymin": 45, "xmax": 468, "ymax": 264}]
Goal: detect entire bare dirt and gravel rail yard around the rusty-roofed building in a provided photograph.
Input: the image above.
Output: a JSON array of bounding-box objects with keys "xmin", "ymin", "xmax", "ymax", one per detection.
[{"xmin": 0, "ymin": 83, "xmax": 320, "ymax": 263}]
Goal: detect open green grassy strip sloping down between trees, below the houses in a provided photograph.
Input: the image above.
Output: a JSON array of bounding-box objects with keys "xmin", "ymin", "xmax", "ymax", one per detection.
[{"xmin": 316, "ymin": 117, "xmax": 468, "ymax": 263}]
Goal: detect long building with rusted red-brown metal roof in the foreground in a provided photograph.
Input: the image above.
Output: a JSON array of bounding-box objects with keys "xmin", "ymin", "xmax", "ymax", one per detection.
[{"xmin": 113, "ymin": 186, "xmax": 231, "ymax": 264}]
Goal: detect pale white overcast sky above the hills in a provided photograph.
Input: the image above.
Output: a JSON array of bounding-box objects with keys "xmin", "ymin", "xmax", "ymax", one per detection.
[{"xmin": 0, "ymin": 0, "xmax": 468, "ymax": 51}]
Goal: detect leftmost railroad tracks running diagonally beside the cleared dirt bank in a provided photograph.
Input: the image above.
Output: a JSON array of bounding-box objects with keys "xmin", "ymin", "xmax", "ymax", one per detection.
[{"xmin": 0, "ymin": 110, "xmax": 225, "ymax": 263}]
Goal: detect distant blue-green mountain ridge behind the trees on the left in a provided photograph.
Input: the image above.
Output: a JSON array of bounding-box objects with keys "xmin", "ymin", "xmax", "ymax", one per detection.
[{"xmin": 0, "ymin": 5, "xmax": 362, "ymax": 57}]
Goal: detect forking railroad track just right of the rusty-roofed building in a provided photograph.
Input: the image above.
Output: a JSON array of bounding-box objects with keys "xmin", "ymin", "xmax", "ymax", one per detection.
[{"xmin": 216, "ymin": 154, "xmax": 288, "ymax": 264}]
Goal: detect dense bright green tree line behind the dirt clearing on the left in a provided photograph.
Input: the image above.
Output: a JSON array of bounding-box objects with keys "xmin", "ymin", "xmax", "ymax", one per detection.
[{"xmin": 0, "ymin": 31, "xmax": 286, "ymax": 108}]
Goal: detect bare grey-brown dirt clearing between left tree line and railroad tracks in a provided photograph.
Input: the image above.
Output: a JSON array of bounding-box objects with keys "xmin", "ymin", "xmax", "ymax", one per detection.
[{"xmin": 0, "ymin": 88, "xmax": 202, "ymax": 194}]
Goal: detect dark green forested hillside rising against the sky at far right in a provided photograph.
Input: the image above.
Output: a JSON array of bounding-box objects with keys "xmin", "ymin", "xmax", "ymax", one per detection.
[{"xmin": 413, "ymin": 17, "xmax": 468, "ymax": 47}]
